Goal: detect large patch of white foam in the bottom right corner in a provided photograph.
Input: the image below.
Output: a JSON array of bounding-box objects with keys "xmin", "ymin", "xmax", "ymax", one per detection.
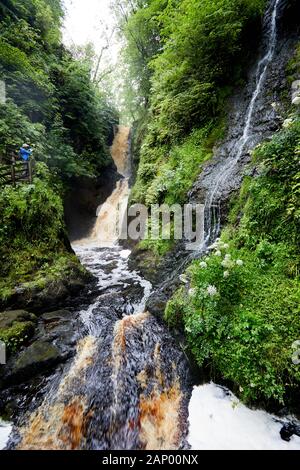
[{"xmin": 188, "ymin": 382, "xmax": 300, "ymax": 450}]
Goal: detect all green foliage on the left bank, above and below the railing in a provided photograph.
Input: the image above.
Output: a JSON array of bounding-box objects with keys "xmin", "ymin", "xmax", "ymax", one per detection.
[{"xmin": 0, "ymin": 0, "xmax": 118, "ymax": 299}]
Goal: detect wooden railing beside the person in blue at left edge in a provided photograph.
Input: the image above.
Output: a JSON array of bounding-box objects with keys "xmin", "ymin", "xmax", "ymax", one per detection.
[{"xmin": 0, "ymin": 157, "xmax": 34, "ymax": 187}]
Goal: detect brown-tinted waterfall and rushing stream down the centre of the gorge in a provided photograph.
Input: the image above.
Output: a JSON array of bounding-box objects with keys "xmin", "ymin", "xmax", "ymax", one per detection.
[{"xmin": 11, "ymin": 127, "xmax": 189, "ymax": 450}]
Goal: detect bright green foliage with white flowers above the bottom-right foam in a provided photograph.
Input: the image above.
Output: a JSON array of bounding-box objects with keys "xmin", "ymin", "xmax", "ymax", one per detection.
[{"xmin": 165, "ymin": 239, "xmax": 300, "ymax": 403}]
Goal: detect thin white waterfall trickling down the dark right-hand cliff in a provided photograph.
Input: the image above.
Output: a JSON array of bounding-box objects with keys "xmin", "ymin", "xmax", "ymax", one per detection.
[{"xmin": 203, "ymin": 0, "xmax": 283, "ymax": 248}]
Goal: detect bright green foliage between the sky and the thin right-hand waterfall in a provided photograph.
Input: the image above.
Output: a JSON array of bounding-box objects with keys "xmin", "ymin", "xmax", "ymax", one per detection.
[{"xmin": 119, "ymin": 0, "xmax": 266, "ymax": 218}]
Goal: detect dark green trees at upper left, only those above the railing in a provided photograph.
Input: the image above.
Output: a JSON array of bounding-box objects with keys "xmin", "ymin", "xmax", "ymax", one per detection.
[{"xmin": 0, "ymin": 0, "xmax": 117, "ymax": 179}]
